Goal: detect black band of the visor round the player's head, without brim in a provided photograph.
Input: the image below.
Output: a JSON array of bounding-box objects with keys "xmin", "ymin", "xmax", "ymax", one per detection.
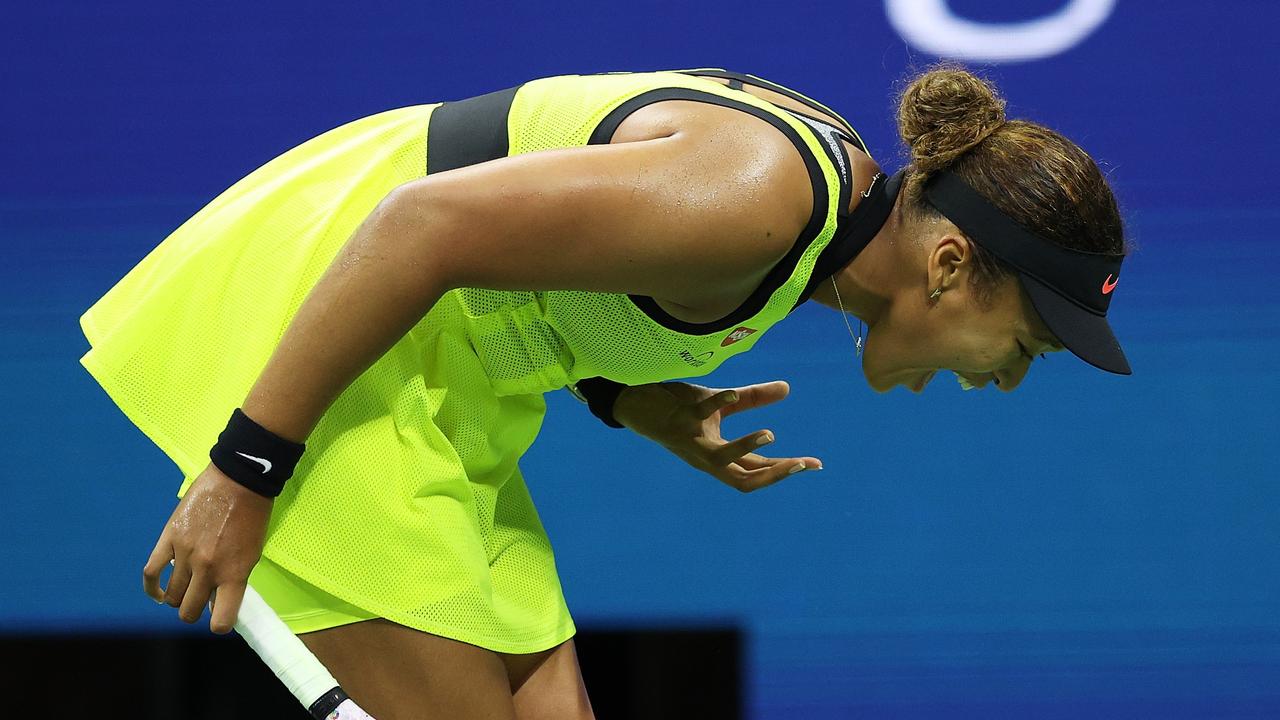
[{"xmin": 924, "ymin": 170, "xmax": 1124, "ymax": 315}]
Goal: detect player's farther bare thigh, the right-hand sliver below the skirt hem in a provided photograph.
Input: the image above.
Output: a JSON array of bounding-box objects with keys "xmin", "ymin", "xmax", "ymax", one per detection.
[{"xmin": 498, "ymin": 639, "xmax": 595, "ymax": 720}]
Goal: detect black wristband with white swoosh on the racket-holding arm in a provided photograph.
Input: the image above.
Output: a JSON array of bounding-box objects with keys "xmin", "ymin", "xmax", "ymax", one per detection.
[{"xmin": 209, "ymin": 407, "xmax": 307, "ymax": 497}]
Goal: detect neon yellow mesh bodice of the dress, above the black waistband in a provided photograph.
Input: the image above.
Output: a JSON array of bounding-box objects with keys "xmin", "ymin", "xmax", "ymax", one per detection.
[{"xmin": 453, "ymin": 72, "xmax": 840, "ymax": 395}]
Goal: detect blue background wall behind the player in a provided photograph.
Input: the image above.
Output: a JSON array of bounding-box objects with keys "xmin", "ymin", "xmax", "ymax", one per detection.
[{"xmin": 0, "ymin": 0, "xmax": 1280, "ymax": 719}]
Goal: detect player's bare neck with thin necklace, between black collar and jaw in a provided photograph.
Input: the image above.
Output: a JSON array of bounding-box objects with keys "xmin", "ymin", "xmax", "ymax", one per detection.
[{"xmin": 809, "ymin": 193, "xmax": 906, "ymax": 325}]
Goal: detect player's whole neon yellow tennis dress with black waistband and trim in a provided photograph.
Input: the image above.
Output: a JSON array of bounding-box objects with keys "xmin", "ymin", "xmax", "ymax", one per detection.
[{"xmin": 81, "ymin": 68, "xmax": 888, "ymax": 653}]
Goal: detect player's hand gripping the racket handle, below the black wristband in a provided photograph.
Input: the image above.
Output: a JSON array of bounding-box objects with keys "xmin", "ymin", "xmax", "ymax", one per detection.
[{"xmin": 142, "ymin": 462, "xmax": 273, "ymax": 633}]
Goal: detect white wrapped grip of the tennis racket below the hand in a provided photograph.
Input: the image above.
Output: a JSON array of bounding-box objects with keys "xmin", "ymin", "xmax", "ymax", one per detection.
[{"xmin": 236, "ymin": 585, "xmax": 340, "ymax": 702}]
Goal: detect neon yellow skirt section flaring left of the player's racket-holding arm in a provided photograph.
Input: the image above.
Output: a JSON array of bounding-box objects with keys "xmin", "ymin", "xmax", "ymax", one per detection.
[{"xmin": 81, "ymin": 108, "xmax": 440, "ymax": 475}]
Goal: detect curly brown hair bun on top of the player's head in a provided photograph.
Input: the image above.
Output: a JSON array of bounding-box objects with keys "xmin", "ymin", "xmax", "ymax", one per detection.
[{"xmin": 897, "ymin": 65, "xmax": 1005, "ymax": 176}]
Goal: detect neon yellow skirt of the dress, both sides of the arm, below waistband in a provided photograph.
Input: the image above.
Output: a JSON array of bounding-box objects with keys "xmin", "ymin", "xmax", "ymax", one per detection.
[{"xmin": 81, "ymin": 105, "xmax": 573, "ymax": 652}]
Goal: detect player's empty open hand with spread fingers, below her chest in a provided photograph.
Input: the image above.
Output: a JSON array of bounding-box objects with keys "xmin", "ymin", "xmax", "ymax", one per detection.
[{"xmin": 613, "ymin": 380, "xmax": 822, "ymax": 492}]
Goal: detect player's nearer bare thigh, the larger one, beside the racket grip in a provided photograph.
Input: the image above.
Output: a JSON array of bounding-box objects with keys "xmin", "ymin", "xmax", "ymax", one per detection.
[{"xmin": 298, "ymin": 619, "xmax": 514, "ymax": 720}]
